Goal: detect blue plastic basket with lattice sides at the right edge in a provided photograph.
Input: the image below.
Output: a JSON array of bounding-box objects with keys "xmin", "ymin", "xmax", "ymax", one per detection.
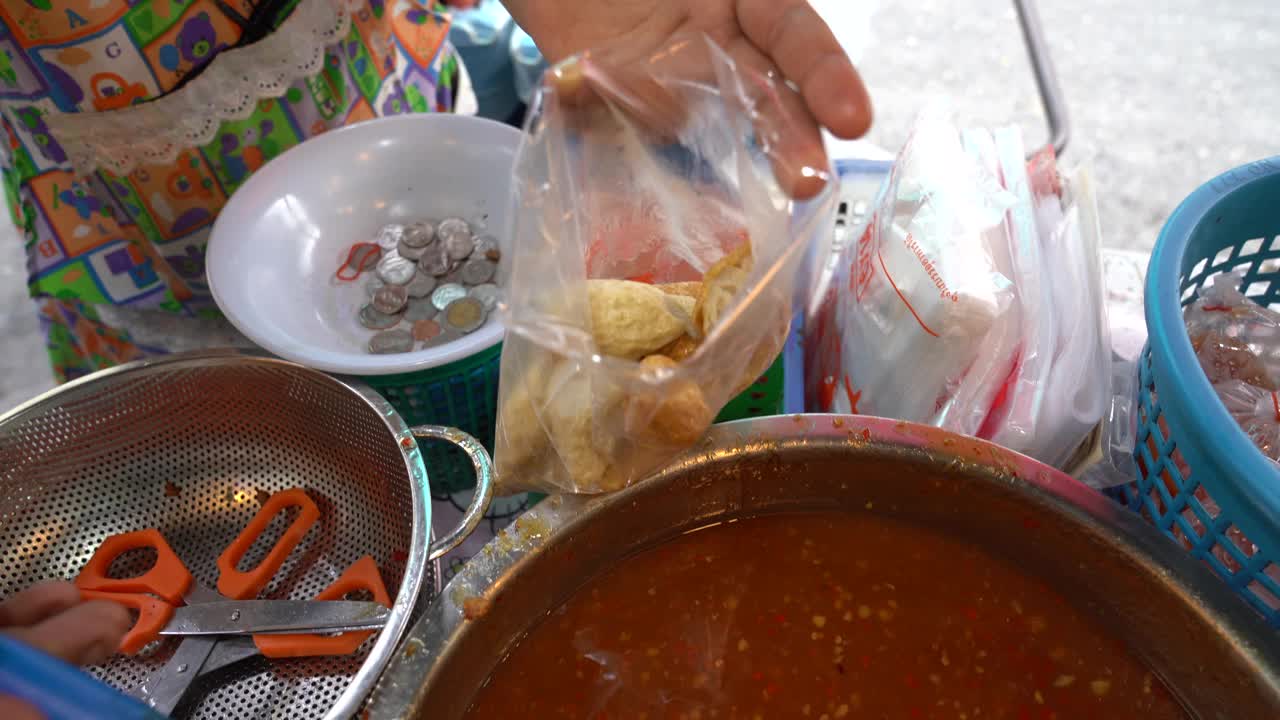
[{"xmin": 1123, "ymin": 158, "xmax": 1280, "ymax": 626}]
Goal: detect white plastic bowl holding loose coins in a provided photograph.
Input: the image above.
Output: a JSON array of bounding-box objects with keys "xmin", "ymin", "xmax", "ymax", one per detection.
[{"xmin": 207, "ymin": 114, "xmax": 521, "ymax": 375}]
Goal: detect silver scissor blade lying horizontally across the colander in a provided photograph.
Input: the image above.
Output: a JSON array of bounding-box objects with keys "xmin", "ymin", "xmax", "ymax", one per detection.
[{"xmin": 160, "ymin": 600, "xmax": 390, "ymax": 635}]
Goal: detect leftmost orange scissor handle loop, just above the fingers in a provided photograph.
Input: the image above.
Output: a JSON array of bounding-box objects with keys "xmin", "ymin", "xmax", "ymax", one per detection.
[{"xmin": 76, "ymin": 528, "xmax": 191, "ymax": 605}]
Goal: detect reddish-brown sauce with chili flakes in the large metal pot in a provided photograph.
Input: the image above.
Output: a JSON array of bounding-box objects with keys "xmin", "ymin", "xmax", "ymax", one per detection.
[{"xmin": 468, "ymin": 514, "xmax": 1187, "ymax": 720}]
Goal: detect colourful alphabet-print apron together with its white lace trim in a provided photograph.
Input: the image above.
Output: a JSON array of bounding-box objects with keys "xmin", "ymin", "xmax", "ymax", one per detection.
[{"xmin": 0, "ymin": 0, "xmax": 470, "ymax": 380}]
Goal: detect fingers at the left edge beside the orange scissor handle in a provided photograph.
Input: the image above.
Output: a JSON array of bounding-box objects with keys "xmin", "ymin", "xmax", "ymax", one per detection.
[{"xmin": 0, "ymin": 582, "xmax": 132, "ymax": 666}]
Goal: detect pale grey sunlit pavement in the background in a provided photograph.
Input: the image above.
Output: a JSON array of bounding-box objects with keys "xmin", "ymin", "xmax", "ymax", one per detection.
[{"xmin": 0, "ymin": 0, "xmax": 1280, "ymax": 411}]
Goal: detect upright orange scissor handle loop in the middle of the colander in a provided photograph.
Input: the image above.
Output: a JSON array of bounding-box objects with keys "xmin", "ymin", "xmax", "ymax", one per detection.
[{"xmin": 218, "ymin": 488, "xmax": 320, "ymax": 600}]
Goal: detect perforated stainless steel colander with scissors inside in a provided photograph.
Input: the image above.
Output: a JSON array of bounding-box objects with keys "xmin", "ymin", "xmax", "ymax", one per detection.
[{"xmin": 0, "ymin": 352, "xmax": 490, "ymax": 719}]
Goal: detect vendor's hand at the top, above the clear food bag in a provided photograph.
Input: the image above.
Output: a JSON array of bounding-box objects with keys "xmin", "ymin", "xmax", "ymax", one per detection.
[{"xmin": 503, "ymin": 0, "xmax": 872, "ymax": 196}]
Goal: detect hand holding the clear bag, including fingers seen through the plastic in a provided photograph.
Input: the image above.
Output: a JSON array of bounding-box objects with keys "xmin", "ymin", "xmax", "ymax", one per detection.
[{"xmin": 504, "ymin": 0, "xmax": 872, "ymax": 197}]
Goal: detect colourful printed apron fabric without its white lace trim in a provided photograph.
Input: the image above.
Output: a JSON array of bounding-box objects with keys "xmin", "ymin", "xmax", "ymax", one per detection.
[{"xmin": 0, "ymin": 0, "xmax": 461, "ymax": 380}]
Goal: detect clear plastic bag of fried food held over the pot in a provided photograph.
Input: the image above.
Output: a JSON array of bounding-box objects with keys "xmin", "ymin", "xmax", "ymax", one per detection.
[{"xmin": 495, "ymin": 36, "xmax": 832, "ymax": 493}]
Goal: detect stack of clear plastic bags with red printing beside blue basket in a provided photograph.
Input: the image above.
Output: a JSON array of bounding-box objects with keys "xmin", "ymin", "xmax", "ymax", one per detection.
[{"xmin": 805, "ymin": 108, "xmax": 1110, "ymax": 466}]
